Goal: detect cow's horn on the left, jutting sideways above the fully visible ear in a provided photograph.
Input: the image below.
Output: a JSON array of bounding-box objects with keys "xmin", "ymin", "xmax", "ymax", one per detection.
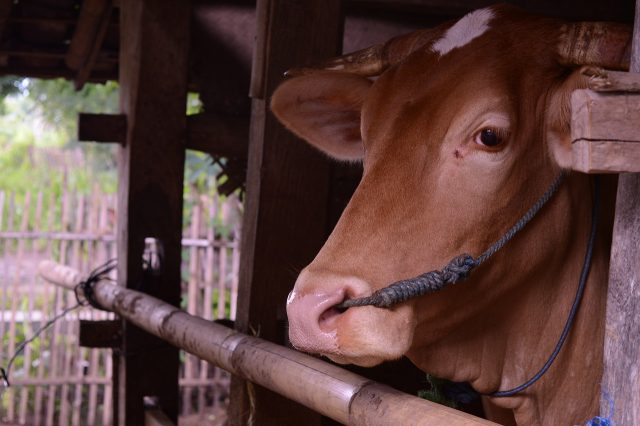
[{"xmin": 286, "ymin": 28, "xmax": 443, "ymax": 77}]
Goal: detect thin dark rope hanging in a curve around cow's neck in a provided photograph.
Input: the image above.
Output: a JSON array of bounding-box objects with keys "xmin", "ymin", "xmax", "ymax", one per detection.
[{"xmin": 487, "ymin": 176, "xmax": 600, "ymax": 397}]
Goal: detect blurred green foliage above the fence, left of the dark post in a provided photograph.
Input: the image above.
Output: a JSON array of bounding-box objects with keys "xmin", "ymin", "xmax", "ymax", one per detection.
[{"xmin": 0, "ymin": 77, "xmax": 118, "ymax": 193}]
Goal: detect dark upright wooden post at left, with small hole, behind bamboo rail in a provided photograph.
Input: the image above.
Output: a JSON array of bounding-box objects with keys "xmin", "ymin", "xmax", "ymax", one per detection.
[{"xmin": 114, "ymin": 0, "xmax": 191, "ymax": 426}]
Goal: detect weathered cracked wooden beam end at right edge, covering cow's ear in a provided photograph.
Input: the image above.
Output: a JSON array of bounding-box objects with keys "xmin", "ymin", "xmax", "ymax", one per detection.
[{"xmin": 571, "ymin": 88, "xmax": 640, "ymax": 173}]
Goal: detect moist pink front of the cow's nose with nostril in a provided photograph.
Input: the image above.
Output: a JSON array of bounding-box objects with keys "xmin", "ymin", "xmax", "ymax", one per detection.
[{"xmin": 287, "ymin": 289, "xmax": 344, "ymax": 354}]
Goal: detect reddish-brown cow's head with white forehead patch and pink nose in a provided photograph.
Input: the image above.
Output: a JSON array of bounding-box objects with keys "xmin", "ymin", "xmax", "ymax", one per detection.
[{"xmin": 272, "ymin": 6, "xmax": 629, "ymax": 372}]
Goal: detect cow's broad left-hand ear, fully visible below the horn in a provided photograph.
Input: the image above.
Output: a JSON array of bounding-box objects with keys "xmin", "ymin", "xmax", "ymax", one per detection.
[{"xmin": 271, "ymin": 72, "xmax": 371, "ymax": 161}]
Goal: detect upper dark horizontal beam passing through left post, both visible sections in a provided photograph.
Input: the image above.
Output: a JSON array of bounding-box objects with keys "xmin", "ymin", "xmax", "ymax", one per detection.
[{"xmin": 78, "ymin": 113, "xmax": 249, "ymax": 160}]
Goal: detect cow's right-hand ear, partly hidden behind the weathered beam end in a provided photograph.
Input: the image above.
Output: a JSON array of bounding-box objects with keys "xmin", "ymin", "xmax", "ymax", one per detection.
[{"xmin": 546, "ymin": 66, "xmax": 608, "ymax": 169}]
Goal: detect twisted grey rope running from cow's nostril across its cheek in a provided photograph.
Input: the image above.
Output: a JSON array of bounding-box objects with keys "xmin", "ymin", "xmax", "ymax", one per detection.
[{"xmin": 335, "ymin": 171, "xmax": 567, "ymax": 309}]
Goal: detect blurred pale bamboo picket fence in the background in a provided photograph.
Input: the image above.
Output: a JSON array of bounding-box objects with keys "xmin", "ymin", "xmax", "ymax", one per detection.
[{"xmin": 0, "ymin": 191, "xmax": 241, "ymax": 426}]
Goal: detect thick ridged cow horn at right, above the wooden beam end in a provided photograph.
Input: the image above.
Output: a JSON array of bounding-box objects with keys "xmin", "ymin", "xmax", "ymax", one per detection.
[{"xmin": 558, "ymin": 22, "xmax": 631, "ymax": 70}]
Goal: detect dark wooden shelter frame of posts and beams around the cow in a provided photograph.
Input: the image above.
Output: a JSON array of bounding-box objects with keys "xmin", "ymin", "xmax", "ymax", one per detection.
[{"xmin": 0, "ymin": 0, "xmax": 640, "ymax": 425}]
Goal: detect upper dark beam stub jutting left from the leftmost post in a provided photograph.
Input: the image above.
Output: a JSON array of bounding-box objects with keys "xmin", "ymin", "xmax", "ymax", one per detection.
[{"xmin": 78, "ymin": 113, "xmax": 127, "ymax": 144}]
